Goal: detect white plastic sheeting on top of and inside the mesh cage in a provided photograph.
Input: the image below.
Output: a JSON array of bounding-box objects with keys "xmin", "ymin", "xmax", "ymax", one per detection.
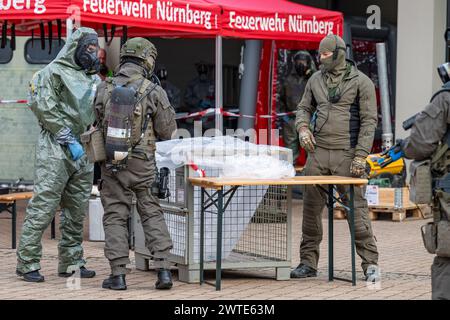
[{"xmin": 156, "ymin": 136, "xmax": 295, "ymax": 262}]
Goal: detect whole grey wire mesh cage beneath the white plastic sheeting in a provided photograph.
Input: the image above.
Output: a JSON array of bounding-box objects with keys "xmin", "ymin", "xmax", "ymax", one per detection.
[{"xmin": 135, "ymin": 166, "xmax": 291, "ymax": 282}]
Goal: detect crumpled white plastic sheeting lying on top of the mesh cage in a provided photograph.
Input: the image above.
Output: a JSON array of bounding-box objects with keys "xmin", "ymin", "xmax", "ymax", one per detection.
[{"xmin": 156, "ymin": 136, "xmax": 295, "ymax": 179}]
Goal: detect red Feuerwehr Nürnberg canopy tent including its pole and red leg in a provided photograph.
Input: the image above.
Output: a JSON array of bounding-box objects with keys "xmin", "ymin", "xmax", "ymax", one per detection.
[{"xmin": 0, "ymin": 0, "xmax": 343, "ymax": 142}]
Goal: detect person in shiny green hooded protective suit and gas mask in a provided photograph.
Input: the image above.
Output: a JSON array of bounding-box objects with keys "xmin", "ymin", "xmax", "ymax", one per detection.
[{"xmin": 16, "ymin": 28, "xmax": 100, "ymax": 282}]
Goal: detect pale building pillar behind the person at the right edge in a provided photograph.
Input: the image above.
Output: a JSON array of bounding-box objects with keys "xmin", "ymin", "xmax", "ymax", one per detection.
[{"xmin": 395, "ymin": 0, "xmax": 447, "ymax": 139}]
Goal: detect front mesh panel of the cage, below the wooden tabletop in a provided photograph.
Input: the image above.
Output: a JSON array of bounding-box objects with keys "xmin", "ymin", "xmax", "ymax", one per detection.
[{"xmin": 198, "ymin": 182, "xmax": 290, "ymax": 268}]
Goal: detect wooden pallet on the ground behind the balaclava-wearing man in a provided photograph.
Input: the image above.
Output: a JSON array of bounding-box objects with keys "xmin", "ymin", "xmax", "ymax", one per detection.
[{"xmin": 334, "ymin": 204, "xmax": 431, "ymax": 222}]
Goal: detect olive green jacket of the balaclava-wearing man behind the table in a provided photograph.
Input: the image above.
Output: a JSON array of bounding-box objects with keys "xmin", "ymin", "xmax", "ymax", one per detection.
[{"xmin": 295, "ymin": 61, "xmax": 378, "ymax": 157}]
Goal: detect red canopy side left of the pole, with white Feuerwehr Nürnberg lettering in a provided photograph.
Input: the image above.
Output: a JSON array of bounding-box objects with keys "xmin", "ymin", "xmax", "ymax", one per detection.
[{"xmin": 0, "ymin": 0, "xmax": 221, "ymax": 37}]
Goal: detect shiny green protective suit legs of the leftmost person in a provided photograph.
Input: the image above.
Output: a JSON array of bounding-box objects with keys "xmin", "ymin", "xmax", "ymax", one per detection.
[{"xmin": 17, "ymin": 152, "xmax": 94, "ymax": 273}]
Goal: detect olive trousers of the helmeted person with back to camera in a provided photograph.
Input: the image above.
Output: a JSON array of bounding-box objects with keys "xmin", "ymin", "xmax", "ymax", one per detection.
[{"xmin": 100, "ymin": 158, "xmax": 172, "ymax": 275}]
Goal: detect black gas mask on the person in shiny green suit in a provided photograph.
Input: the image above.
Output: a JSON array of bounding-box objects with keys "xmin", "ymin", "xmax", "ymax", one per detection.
[{"xmin": 75, "ymin": 34, "xmax": 100, "ymax": 74}]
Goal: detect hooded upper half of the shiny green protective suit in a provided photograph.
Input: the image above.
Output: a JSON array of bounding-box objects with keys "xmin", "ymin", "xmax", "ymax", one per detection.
[{"xmin": 29, "ymin": 28, "xmax": 100, "ymax": 143}]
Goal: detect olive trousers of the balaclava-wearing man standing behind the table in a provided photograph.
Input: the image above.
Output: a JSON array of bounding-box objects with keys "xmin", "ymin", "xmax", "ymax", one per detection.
[{"xmin": 300, "ymin": 147, "xmax": 378, "ymax": 272}]
